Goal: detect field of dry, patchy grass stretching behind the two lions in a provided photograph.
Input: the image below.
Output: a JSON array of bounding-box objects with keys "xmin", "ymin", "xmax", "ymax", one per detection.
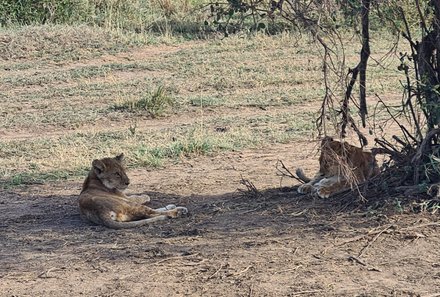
[{"xmin": 0, "ymin": 26, "xmax": 406, "ymax": 185}]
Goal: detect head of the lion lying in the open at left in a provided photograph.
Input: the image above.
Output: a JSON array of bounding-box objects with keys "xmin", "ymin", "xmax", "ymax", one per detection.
[{"xmin": 92, "ymin": 154, "xmax": 130, "ymax": 191}]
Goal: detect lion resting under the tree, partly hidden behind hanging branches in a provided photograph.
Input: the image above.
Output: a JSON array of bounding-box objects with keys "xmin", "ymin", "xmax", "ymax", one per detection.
[{"xmin": 296, "ymin": 136, "xmax": 380, "ymax": 198}]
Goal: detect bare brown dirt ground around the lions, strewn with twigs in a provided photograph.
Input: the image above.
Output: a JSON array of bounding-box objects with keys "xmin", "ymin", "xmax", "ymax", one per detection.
[{"xmin": 0, "ymin": 143, "xmax": 440, "ymax": 296}]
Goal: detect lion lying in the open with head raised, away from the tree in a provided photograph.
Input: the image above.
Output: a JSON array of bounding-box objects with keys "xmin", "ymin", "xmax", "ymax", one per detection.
[{"xmin": 79, "ymin": 154, "xmax": 188, "ymax": 229}]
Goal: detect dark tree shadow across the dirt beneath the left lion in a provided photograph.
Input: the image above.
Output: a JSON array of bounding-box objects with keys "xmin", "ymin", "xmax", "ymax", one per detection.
[{"xmin": 0, "ymin": 187, "xmax": 396, "ymax": 272}]
